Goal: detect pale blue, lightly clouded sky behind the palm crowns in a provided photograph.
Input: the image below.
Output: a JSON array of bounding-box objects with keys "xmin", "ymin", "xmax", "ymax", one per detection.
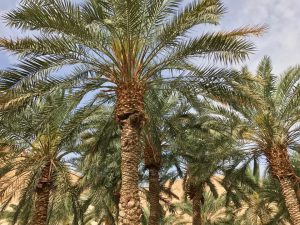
[{"xmin": 0, "ymin": 0, "xmax": 300, "ymax": 74}]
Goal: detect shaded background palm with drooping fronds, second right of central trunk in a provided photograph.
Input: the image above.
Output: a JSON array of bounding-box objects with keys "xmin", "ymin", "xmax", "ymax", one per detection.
[{"xmin": 168, "ymin": 108, "xmax": 238, "ymax": 225}]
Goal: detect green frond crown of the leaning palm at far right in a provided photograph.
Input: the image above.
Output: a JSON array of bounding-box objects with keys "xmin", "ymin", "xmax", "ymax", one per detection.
[{"xmin": 215, "ymin": 57, "xmax": 300, "ymax": 176}]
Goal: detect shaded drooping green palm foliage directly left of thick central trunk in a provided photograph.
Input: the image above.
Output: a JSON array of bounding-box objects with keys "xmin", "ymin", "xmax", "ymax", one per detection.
[{"xmin": 77, "ymin": 106, "xmax": 121, "ymax": 225}]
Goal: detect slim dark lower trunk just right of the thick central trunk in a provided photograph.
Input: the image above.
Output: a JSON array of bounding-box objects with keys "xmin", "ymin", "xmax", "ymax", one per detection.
[{"xmin": 149, "ymin": 166, "xmax": 160, "ymax": 225}]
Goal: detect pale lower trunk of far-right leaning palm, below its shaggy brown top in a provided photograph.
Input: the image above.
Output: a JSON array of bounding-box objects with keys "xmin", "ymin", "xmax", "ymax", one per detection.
[{"xmin": 279, "ymin": 178, "xmax": 300, "ymax": 225}]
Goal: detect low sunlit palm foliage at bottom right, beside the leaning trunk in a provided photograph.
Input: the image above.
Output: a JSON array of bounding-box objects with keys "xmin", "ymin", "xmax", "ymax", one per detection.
[{"xmin": 222, "ymin": 158, "xmax": 290, "ymax": 225}]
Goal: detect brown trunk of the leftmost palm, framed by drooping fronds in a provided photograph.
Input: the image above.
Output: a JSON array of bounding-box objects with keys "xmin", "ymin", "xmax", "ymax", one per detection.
[{"xmin": 31, "ymin": 163, "xmax": 52, "ymax": 225}]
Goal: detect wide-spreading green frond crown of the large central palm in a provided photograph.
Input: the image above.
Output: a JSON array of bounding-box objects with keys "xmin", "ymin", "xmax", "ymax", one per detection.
[{"xmin": 0, "ymin": 0, "xmax": 264, "ymax": 110}]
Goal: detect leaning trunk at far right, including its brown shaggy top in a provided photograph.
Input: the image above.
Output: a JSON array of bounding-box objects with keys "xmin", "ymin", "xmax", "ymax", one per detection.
[{"xmin": 265, "ymin": 147, "xmax": 300, "ymax": 225}]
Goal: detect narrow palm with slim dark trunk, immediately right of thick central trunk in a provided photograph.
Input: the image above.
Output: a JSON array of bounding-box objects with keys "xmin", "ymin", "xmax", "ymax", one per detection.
[{"xmin": 142, "ymin": 85, "xmax": 182, "ymax": 225}]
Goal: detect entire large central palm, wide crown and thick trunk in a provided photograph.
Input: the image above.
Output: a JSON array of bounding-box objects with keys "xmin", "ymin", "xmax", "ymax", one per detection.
[{"xmin": 0, "ymin": 0, "xmax": 263, "ymax": 224}]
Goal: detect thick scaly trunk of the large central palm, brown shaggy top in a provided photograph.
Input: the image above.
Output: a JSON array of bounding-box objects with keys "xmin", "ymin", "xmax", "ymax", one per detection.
[{"xmin": 115, "ymin": 82, "xmax": 145, "ymax": 225}]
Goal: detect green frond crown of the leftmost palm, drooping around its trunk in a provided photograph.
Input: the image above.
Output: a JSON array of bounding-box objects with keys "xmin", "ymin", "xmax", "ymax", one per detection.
[{"xmin": 0, "ymin": 91, "xmax": 100, "ymax": 224}]
